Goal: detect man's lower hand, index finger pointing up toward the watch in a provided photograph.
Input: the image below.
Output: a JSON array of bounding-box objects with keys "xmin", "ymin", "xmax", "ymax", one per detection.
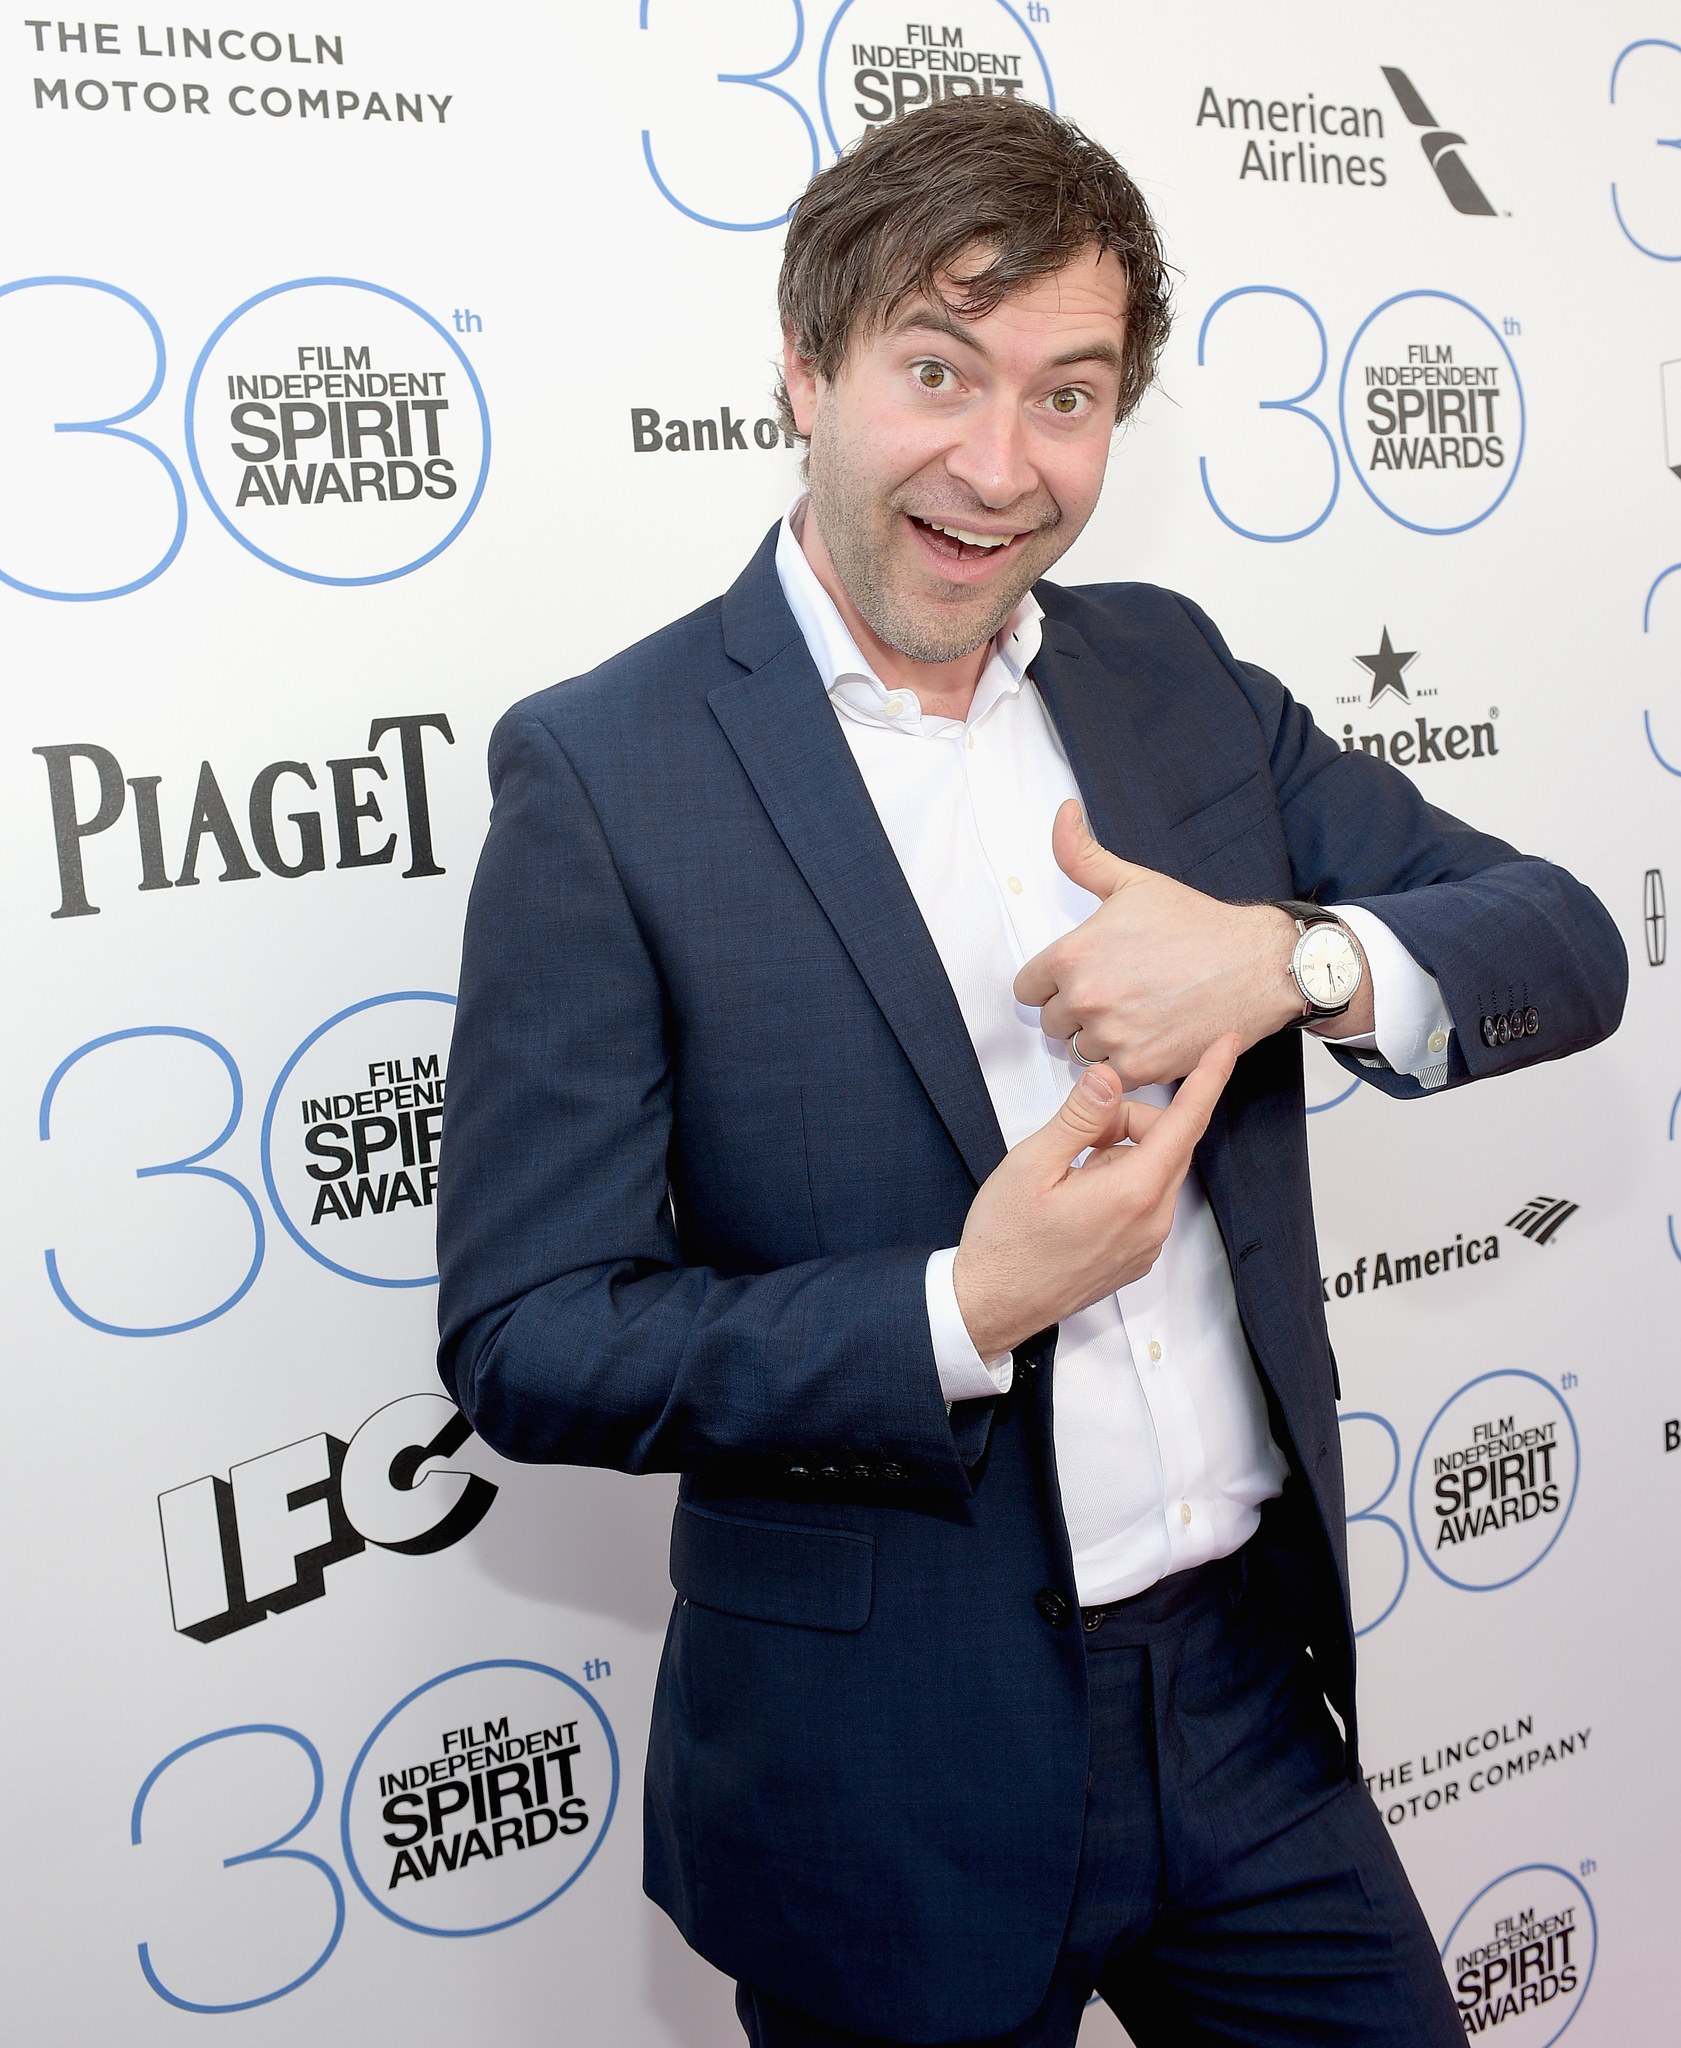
[{"xmin": 952, "ymin": 1034, "xmax": 1239, "ymax": 1360}]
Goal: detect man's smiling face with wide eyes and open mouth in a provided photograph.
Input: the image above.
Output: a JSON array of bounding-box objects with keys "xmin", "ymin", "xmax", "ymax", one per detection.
[{"xmin": 786, "ymin": 250, "xmax": 1126, "ymax": 662}]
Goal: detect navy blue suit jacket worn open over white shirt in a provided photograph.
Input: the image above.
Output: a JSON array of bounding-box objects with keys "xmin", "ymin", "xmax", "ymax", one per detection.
[{"xmin": 438, "ymin": 532, "xmax": 1628, "ymax": 2040}]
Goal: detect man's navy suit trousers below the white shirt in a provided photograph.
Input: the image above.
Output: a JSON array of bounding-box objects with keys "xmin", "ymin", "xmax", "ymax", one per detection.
[{"xmin": 735, "ymin": 1544, "xmax": 1464, "ymax": 2048}]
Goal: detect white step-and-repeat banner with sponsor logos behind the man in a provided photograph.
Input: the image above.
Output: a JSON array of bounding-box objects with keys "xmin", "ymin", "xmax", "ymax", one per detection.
[{"xmin": 0, "ymin": 0, "xmax": 1681, "ymax": 2048}]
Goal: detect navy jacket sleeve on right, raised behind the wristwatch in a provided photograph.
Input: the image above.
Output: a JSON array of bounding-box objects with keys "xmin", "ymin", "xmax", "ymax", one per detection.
[{"xmin": 1179, "ymin": 598, "xmax": 1628, "ymax": 1098}]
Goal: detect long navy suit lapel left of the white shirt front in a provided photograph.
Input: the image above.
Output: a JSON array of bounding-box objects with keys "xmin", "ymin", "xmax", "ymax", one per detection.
[{"xmin": 708, "ymin": 532, "xmax": 1005, "ymax": 1186}]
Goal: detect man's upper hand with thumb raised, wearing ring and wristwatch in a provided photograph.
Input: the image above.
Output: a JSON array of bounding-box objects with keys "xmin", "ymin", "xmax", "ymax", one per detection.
[{"xmin": 1016, "ymin": 799, "xmax": 1370, "ymax": 1087}]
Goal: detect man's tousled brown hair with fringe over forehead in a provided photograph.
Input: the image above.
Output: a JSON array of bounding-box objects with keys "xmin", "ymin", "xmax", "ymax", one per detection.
[{"xmin": 776, "ymin": 94, "xmax": 1171, "ymax": 434}]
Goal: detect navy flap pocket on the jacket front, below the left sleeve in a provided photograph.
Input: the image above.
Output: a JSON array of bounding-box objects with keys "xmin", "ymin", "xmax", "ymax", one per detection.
[{"xmin": 672, "ymin": 1503, "xmax": 876, "ymax": 1634}]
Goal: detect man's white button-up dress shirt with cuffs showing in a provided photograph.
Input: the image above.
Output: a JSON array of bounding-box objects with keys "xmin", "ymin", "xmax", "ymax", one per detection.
[{"xmin": 776, "ymin": 498, "xmax": 1446, "ymax": 1606}]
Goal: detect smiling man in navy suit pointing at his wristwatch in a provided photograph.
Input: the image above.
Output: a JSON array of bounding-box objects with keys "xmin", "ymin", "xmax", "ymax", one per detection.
[{"xmin": 438, "ymin": 100, "xmax": 1626, "ymax": 2048}]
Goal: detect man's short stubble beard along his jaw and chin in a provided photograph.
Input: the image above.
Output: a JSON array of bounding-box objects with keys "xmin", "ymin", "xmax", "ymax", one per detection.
[{"xmin": 807, "ymin": 422, "xmax": 1075, "ymax": 662}]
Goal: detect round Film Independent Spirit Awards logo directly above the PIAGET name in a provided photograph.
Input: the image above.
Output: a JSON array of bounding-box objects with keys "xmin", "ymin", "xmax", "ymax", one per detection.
[{"xmin": 186, "ymin": 276, "xmax": 489, "ymax": 584}]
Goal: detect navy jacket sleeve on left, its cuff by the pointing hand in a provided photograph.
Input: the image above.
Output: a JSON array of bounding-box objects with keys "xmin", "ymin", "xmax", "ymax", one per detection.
[{"xmin": 438, "ymin": 711, "xmax": 991, "ymax": 1495}]
